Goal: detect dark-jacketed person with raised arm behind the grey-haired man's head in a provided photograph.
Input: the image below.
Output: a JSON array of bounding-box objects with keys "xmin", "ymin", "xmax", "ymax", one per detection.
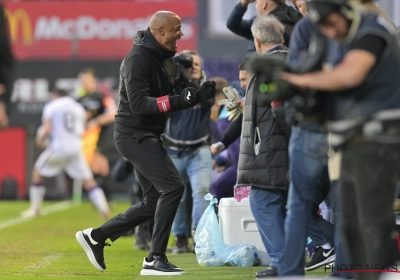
[{"xmin": 226, "ymin": 0, "xmax": 301, "ymax": 53}]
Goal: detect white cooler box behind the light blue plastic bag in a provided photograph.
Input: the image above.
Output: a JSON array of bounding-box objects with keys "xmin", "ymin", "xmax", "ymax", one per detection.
[{"xmin": 218, "ymin": 197, "xmax": 271, "ymax": 265}]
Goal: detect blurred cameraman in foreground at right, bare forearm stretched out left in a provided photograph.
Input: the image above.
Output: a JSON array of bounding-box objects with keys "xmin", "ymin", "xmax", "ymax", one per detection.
[{"xmin": 278, "ymin": 0, "xmax": 400, "ymax": 280}]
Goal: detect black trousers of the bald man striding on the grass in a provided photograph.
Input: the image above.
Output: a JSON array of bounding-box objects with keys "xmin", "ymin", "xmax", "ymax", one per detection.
[{"xmin": 100, "ymin": 130, "xmax": 184, "ymax": 254}]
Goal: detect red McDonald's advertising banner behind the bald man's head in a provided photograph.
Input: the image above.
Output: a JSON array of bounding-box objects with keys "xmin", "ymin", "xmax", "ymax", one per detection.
[{"xmin": 4, "ymin": 0, "xmax": 197, "ymax": 60}]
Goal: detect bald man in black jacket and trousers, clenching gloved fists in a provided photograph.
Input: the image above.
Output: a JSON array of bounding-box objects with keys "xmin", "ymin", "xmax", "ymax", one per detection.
[{"xmin": 76, "ymin": 11, "xmax": 215, "ymax": 275}]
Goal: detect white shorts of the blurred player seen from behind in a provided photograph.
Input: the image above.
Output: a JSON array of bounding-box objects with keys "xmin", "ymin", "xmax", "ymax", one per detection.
[{"xmin": 35, "ymin": 147, "xmax": 93, "ymax": 180}]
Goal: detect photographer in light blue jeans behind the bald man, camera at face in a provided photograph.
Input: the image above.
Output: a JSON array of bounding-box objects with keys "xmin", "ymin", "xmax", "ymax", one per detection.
[{"xmin": 163, "ymin": 51, "xmax": 214, "ymax": 254}]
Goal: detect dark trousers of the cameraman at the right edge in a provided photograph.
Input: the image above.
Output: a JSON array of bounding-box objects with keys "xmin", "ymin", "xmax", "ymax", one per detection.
[{"xmin": 338, "ymin": 141, "xmax": 400, "ymax": 280}]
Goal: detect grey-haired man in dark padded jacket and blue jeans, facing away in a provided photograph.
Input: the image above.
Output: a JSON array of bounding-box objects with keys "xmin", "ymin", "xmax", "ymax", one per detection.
[{"xmin": 211, "ymin": 16, "xmax": 290, "ymax": 277}]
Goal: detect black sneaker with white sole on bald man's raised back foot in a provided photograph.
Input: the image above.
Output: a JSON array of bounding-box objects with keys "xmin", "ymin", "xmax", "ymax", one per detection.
[{"xmin": 75, "ymin": 228, "xmax": 111, "ymax": 272}]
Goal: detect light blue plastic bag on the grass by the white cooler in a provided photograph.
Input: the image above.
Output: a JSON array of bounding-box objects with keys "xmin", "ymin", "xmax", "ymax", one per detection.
[{"xmin": 194, "ymin": 194, "xmax": 259, "ymax": 266}]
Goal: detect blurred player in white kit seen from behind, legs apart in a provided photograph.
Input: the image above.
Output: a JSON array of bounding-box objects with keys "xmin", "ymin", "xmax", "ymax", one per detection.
[{"xmin": 21, "ymin": 89, "xmax": 110, "ymax": 218}]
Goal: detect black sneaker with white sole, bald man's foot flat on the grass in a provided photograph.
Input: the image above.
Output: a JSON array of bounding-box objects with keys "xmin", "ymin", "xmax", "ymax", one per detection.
[{"xmin": 140, "ymin": 256, "xmax": 185, "ymax": 275}]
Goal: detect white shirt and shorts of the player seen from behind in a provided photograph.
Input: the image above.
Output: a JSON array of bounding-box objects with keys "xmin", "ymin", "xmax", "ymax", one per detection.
[{"xmin": 35, "ymin": 96, "xmax": 93, "ymax": 180}]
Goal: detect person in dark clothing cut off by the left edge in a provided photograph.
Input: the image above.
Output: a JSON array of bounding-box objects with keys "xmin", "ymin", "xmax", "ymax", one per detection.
[{"xmin": 0, "ymin": 3, "xmax": 14, "ymax": 130}]
